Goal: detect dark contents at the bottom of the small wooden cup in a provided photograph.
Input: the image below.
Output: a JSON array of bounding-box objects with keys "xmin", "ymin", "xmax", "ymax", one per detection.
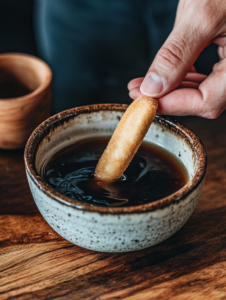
[{"xmin": 0, "ymin": 82, "xmax": 31, "ymax": 99}]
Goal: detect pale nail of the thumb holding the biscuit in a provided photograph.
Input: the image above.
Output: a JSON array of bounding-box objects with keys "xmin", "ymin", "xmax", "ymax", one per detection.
[{"xmin": 140, "ymin": 72, "xmax": 164, "ymax": 97}]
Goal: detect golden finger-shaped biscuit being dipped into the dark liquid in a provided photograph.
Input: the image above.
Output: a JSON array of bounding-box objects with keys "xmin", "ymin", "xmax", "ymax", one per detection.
[{"xmin": 94, "ymin": 96, "xmax": 158, "ymax": 182}]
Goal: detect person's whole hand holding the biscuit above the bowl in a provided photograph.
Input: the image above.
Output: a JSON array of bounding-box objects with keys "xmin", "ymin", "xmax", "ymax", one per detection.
[{"xmin": 128, "ymin": 0, "xmax": 226, "ymax": 119}]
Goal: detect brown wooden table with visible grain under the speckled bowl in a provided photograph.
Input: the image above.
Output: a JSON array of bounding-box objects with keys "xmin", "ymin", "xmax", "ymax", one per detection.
[{"xmin": 0, "ymin": 114, "xmax": 226, "ymax": 300}]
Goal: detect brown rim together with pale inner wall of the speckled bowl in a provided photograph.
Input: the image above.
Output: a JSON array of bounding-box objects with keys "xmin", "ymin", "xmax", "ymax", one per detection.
[{"xmin": 25, "ymin": 104, "xmax": 206, "ymax": 214}]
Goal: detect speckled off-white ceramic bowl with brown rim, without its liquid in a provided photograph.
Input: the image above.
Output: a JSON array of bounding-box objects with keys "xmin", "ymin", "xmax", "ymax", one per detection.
[{"xmin": 25, "ymin": 104, "xmax": 206, "ymax": 252}]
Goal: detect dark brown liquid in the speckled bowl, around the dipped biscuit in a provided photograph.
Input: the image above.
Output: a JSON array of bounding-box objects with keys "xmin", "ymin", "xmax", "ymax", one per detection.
[{"xmin": 42, "ymin": 137, "xmax": 188, "ymax": 207}]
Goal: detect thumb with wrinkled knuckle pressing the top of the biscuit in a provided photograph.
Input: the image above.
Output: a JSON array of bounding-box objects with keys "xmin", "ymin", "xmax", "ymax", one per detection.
[{"xmin": 140, "ymin": 23, "xmax": 208, "ymax": 97}]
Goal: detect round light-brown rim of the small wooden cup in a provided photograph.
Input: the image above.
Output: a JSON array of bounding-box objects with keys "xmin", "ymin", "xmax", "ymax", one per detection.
[{"xmin": 0, "ymin": 52, "xmax": 53, "ymax": 105}]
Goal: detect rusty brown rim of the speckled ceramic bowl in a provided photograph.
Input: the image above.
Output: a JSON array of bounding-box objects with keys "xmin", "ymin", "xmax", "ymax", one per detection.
[{"xmin": 24, "ymin": 104, "xmax": 207, "ymax": 214}]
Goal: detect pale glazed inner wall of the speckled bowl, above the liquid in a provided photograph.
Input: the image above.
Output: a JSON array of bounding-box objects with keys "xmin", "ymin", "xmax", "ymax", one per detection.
[{"xmin": 35, "ymin": 110, "xmax": 197, "ymax": 184}]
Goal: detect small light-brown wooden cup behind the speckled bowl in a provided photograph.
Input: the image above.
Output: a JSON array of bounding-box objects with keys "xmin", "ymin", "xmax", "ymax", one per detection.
[{"xmin": 0, "ymin": 53, "xmax": 52, "ymax": 149}]
